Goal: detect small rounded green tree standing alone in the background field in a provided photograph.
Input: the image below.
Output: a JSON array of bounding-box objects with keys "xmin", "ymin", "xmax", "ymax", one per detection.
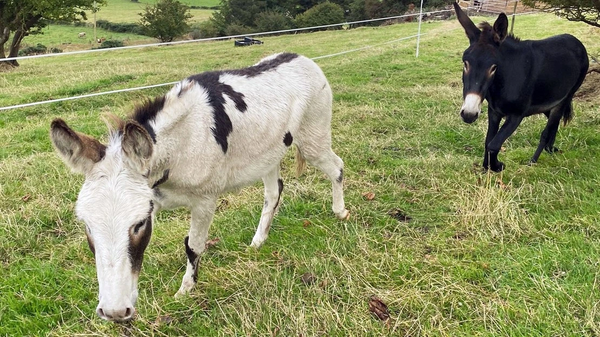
[{"xmin": 139, "ymin": 0, "xmax": 192, "ymax": 42}]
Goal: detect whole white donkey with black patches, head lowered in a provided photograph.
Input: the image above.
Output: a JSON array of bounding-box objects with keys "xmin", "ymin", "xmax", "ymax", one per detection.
[{"xmin": 50, "ymin": 53, "xmax": 349, "ymax": 321}]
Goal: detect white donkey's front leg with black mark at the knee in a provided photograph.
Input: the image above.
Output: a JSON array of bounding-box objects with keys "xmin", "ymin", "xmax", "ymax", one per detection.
[{"xmin": 175, "ymin": 196, "xmax": 217, "ymax": 296}]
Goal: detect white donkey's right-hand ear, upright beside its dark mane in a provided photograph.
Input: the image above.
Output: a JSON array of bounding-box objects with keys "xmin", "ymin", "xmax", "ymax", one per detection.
[{"xmin": 121, "ymin": 121, "xmax": 154, "ymax": 174}]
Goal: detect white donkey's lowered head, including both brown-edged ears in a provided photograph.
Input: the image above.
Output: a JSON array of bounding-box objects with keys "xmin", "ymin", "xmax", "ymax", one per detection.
[{"xmin": 51, "ymin": 119, "xmax": 154, "ymax": 321}]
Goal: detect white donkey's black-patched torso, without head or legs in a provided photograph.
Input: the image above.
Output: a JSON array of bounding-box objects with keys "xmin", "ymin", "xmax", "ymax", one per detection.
[{"xmin": 150, "ymin": 53, "xmax": 339, "ymax": 193}]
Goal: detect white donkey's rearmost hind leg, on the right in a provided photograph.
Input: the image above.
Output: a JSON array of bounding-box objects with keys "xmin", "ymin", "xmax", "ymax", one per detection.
[{"xmin": 296, "ymin": 142, "xmax": 350, "ymax": 220}]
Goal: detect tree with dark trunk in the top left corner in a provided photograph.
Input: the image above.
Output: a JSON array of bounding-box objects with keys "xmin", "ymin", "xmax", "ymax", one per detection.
[{"xmin": 0, "ymin": 0, "xmax": 105, "ymax": 67}]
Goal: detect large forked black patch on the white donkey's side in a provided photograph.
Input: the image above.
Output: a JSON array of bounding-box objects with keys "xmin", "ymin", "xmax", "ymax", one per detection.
[{"xmin": 188, "ymin": 71, "xmax": 248, "ymax": 153}]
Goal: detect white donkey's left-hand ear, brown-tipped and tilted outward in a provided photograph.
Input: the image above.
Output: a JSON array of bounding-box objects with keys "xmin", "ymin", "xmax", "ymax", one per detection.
[{"xmin": 50, "ymin": 118, "xmax": 106, "ymax": 174}]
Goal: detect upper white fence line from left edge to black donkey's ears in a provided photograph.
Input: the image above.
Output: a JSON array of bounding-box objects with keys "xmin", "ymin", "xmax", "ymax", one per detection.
[{"xmin": 0, "ymin": 9, "xmax": 452, "ymax": 62}]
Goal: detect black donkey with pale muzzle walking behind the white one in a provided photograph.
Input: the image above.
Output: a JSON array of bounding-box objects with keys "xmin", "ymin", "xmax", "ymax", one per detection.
[{"xmin": 454, "ymin": 3, "xmax": 589, "ymax": 172}]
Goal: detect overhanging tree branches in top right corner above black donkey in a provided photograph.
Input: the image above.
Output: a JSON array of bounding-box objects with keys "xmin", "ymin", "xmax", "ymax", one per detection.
[{"xmin": 523, "ymin": 0, "xmax": 600, "ymax": 28}]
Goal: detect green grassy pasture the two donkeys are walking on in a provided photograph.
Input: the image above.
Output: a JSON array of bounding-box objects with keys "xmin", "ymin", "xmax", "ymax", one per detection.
[{"xmin": 0, "ymin": 14, "xmax": 600, "ymax": 336}]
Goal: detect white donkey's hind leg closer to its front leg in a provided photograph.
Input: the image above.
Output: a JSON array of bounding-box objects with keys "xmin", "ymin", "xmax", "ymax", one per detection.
[{"xmin": 250, "ymin": 163, "xmax": 283, "ymax": 248}]
